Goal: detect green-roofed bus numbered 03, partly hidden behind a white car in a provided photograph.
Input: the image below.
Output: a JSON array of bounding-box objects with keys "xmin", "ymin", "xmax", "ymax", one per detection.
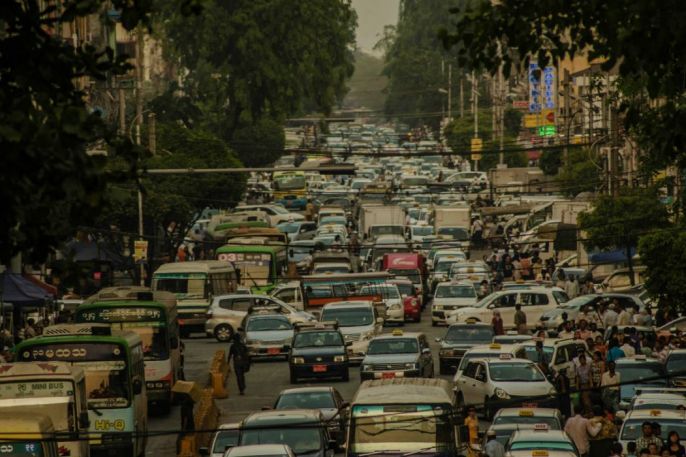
[{"xmin": 216, "ymin": 239, "xmax": 288, "ymax": 293}]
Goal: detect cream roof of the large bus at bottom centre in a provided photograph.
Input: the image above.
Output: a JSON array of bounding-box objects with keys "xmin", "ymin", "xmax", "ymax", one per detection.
[{"xmin": 352, "ymin": 378, "xmax": 453, "ymax": 405}]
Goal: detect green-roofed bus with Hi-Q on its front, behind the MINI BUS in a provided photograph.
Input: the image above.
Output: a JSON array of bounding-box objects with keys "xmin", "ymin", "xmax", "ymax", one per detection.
[{"xmin": 15, "ymin": 324, "xmax": 148, "ymax": 456}]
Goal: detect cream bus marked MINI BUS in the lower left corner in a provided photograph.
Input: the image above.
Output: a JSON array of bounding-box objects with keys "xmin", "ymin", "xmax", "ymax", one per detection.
[{"xmin": 0, "ymin": 362, "xmax": 89, "ymax": 457}]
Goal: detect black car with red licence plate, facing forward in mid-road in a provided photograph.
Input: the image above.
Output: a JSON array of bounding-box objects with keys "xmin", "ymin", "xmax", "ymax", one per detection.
[{"xmin": 288, "ymin": 322, "xmax": 349, "ymax": 384}]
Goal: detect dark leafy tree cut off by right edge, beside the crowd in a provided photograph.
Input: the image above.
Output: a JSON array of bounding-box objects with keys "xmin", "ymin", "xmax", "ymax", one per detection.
[{"xmin": 638, "ymin": 227, "xmax": 686, "ymax": 311}]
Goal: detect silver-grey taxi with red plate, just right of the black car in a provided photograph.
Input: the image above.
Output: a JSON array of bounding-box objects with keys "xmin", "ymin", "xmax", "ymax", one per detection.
[{"xmin": 360, "ymin": 329, "xmax": 434, "ymax": 381}]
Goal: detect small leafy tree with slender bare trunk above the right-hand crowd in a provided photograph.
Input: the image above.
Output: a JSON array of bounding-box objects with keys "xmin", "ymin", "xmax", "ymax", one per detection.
[{"xmin": 578, "ymin": 189, "xmax": 669, "ymax": 285}]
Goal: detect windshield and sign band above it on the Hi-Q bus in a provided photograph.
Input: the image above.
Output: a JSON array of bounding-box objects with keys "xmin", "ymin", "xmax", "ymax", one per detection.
[{"xmin": 18, "ymin": 342, "xmax": 131, "ymax": 409}]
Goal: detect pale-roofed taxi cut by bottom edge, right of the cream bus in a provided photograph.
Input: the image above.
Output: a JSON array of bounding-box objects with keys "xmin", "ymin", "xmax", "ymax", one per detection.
[{"xmin": 505, "ymin": 424, "xmax": 579, "ymax": 457}]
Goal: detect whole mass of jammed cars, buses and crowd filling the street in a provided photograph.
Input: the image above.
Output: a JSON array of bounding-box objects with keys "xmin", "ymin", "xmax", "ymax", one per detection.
[{"xmin": 0, "ymin": 124, "xmax": 686, "ymax": 457}]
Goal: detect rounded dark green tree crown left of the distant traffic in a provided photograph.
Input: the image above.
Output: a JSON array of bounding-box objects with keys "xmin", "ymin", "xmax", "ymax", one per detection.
[{"xmin": 231, "ymin": 119, "xmax": 286, "ymax": 167}]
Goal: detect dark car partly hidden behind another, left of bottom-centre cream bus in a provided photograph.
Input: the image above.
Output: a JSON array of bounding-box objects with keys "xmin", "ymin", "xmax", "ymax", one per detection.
[{"xmin": 274, "ymin": 386, "xmax": 348, "ymax": 446}]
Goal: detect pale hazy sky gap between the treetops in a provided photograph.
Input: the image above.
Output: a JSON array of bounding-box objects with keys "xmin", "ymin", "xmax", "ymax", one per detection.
[{"xmin": 353, "ymin": 0, "xmax": 400, "ymax": 53}]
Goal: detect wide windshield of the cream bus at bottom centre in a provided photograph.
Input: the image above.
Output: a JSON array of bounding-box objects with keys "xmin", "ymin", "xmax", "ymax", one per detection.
[{"xmin": 350, "ymin": 405, "xmax": 453, "ymax": 454}]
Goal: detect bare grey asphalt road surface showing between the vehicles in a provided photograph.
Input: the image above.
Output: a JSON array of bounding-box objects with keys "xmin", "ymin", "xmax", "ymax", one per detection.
[{"xmin": 147, "ymin": 307, "xmax": 468, "ymax": 455}]
